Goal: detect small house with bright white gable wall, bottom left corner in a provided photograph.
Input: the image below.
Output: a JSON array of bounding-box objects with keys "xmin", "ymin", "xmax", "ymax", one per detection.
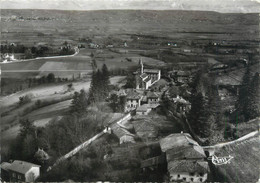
[{"xmin": 1, "ymin": 160, "xmax": 41, "ymax": 182}]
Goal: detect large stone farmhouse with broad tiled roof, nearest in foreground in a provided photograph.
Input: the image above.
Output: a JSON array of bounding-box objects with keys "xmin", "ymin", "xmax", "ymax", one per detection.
[{"xmin": 160, "ymin": 133, "xmax": 209, "ymax": 182}]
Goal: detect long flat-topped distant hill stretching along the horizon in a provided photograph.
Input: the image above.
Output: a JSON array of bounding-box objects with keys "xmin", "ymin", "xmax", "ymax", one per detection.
[{"xmin": 1, "ymin": 10, "xmax": 259, "ymax": 45}]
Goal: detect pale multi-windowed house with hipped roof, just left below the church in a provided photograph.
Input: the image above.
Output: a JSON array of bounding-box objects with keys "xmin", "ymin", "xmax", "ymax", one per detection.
[{"xmin": 126, "ymin": 91, "xmax": 142, "ymax": 112}]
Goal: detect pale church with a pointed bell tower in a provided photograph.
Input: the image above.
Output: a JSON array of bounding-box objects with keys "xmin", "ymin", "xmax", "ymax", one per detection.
[{"xmin": 134, "ymin": 60, "xmax": 161, "ymax": 90}]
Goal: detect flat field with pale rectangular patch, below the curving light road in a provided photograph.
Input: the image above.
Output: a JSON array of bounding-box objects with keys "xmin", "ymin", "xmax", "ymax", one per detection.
[{"xmin": 0, "ymin": 50, "xmax": 92, "ymax": 79}]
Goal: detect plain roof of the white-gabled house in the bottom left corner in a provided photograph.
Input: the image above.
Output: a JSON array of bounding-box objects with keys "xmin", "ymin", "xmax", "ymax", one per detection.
[{"xmin": 6, "ymin": 160, "xmax": 41, "ymax": 174}]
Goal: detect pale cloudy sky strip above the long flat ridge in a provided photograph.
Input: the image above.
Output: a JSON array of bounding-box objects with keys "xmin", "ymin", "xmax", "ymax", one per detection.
[{"xmin": 0, "ymin": 0, "xmax": 260, "ymax": 13}]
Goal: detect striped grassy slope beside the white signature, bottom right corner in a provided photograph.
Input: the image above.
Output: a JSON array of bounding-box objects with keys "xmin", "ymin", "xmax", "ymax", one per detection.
[{"xmin": 211, "ymin": 133, "xmax": 260, "ymax": 182}]
